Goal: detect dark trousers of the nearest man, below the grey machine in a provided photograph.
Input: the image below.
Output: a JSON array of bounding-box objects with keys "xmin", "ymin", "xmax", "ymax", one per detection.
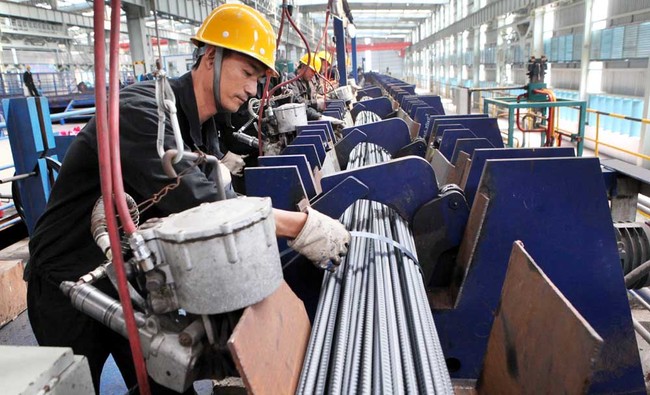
[{"xmin": 27, "ymin": 274, "xmax": 195, "ymax": 395}]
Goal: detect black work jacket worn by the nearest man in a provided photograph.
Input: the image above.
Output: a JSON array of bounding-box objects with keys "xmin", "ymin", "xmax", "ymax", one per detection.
[{"xmin": 26, "ymin": 73, "xmax": 222, "ymax": 283}]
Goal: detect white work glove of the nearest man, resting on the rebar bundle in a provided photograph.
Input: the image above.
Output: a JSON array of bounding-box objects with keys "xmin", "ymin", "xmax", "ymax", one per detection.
[{"xmin": 287, "ymin": 207, "xmax": 350, "ymax": 272}]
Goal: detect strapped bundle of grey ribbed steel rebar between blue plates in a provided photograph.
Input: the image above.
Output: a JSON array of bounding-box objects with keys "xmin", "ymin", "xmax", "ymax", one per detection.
[{"xmin": 297, "ymin": 144, "xmax": 452, "ymax": 394}]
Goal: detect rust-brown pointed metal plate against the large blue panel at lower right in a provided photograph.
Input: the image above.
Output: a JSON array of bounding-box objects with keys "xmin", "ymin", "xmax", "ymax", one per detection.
[{"xmin": 478, "ymin": 241, "xmax": 603, "ymax": 394}]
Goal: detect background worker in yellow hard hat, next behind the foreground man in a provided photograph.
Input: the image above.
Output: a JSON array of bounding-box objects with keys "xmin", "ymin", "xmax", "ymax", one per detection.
[{"xmin": 288, "ymin": 54, "xmax": 343, "ymax": 125}]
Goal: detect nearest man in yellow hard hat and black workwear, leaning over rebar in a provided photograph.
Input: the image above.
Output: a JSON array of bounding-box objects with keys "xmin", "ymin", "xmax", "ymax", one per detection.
[{"xmin": 25, "ymin": 4, "xmax": 350, "ymax": 394}]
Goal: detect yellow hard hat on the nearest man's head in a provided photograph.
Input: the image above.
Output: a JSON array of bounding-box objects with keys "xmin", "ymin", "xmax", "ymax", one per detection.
[{"xmin": 192, "ymin": 4, "xmax": 277, "ymax": 76}]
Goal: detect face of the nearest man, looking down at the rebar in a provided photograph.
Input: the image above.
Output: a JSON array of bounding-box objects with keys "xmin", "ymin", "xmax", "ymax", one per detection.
[{"xmin": 219, "ymin": 52, "xmax": 266, "ymax": 112}]
